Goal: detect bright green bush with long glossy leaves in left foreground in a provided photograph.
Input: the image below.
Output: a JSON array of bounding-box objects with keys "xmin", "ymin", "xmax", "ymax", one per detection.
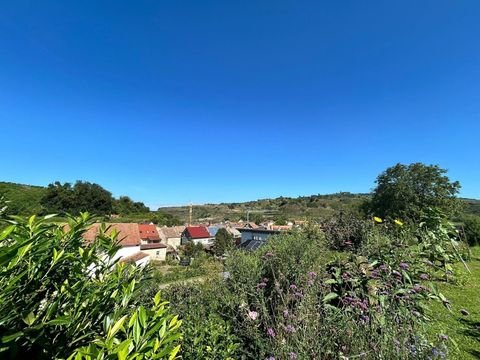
[{"xmin": 0, "ymin": 214, "xmax": 180, "ymax": 359}]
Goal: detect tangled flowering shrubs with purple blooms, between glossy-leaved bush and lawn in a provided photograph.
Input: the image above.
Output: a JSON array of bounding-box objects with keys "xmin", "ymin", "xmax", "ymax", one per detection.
[{"xmin": 147, "ymin": 217, "xmax": 465, "ymax": 359}]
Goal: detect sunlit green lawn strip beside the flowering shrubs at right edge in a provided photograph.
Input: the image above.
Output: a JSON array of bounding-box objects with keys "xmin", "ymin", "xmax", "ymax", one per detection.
[{"xmin": 428, "ymin": 247, "xmax": 480, "ymax": 360}]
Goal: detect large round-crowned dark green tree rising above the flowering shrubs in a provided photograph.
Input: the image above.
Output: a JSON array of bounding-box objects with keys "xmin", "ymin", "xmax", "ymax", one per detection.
[{"xmin": 367, "ymin": 163, "xmax": 460, "ymax": 221}]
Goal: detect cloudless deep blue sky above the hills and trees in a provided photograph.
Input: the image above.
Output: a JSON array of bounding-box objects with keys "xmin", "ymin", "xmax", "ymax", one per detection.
[{"xmin": 0, "ymin": 0, "xmax": 480, "ymax": 207}]
